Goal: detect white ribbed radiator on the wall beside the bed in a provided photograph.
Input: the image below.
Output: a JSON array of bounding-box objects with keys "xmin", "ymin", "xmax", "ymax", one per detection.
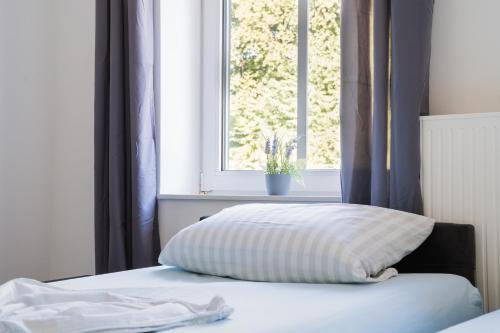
[{"xmin": 421, "ymin": 113, "xmax": 500, "ymax": 311}]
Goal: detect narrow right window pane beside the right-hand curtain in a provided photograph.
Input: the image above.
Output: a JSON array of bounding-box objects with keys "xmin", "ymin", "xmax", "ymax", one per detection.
[{"xmin": 307, "ymin": 0, "xmax": 340, "ymax": 169}]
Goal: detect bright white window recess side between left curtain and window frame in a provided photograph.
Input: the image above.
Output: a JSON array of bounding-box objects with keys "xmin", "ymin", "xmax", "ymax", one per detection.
[{"xmin": 157, "ymin": 0, "xmax": 201, "ymax": 193}]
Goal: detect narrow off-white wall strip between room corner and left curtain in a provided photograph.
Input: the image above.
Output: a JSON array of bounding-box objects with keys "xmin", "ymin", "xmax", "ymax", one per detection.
[{"xmin": 49, "ymin": 0, "xmax": 95, "ymax": 278}]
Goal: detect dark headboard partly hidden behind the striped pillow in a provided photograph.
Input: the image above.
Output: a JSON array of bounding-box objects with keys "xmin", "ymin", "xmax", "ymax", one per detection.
[{"xmin": 200, "ymin": 216, "xmax": 476, "ymax": 285}]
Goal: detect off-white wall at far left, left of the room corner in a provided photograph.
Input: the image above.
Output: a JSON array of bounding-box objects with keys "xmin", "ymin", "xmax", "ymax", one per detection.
[{"xmin": 0, "ymin": 0, "xmax": 54, "ymax": 282}]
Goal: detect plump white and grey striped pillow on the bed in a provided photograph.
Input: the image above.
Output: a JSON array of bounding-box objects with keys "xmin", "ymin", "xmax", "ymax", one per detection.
[{"xmin": 159, "ymin": 204, "xmax": 434, "ymax": 283}]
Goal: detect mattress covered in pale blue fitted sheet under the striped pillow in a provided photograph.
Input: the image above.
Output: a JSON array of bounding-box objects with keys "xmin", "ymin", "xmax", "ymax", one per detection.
[{"xmin": 54, "ymin": 267, "xmax": 483, "ymax": 333}]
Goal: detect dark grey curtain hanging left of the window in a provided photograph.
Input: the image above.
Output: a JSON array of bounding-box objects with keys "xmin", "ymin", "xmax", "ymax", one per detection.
[{"xmin": 94, "ymin": 0, "xmax": 160, "ymax": 273}]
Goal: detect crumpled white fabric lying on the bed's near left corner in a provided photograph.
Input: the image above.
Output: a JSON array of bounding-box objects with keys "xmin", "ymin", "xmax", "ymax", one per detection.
[{"xmin": 0, "ymin": 279, "xmax": 233, "ymax": 333}]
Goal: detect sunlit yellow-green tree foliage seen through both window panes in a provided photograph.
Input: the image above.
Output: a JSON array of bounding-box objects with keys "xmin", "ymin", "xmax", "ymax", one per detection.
[{"xmin": 229, "ymin": 0, "xmax": 340, "ymax": 170}]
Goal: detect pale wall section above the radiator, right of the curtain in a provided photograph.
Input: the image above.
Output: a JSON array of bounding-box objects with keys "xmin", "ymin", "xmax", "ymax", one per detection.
[{"xmin": 430, "ymin": 0, "xmax": 500, "ymax": 114}]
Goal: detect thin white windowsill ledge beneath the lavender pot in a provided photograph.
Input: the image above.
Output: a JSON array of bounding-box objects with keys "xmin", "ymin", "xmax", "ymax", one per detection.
[{"xmin": 157, "ymin": 193, "xmax": 341, "ymax": 202}]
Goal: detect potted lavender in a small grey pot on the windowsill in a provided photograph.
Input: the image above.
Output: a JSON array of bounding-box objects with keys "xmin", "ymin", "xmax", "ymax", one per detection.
[{"xmin": 264, "ymin": 134, "xmax": 301, "ymax": 195}]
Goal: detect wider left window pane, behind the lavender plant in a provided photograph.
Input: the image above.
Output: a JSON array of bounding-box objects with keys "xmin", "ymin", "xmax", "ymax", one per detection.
[{"xmin": 225, "ymin": 0, "xmax": 298, "ymax": 170}]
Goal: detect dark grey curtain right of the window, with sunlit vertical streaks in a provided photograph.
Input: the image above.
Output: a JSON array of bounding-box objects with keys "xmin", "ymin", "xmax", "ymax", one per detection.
[{"xmin": 340, "ymin": 0, "xmax": 434, "ymax": 214}]
